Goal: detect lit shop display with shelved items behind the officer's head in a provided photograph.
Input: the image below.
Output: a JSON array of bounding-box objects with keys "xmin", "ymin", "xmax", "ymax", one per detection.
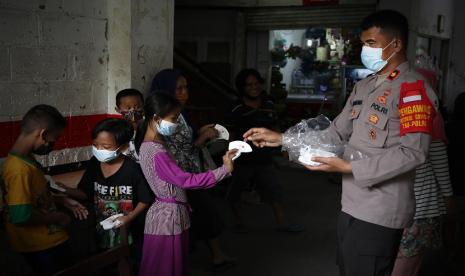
[{"xmin": 269, "ymin": 27, "xmax": 361, "ymax": 120}]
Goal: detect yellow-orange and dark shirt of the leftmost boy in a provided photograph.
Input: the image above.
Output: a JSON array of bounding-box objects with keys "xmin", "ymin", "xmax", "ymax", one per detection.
[{"xmin": 3, "ymin": 153, "xmax": 68, "ymax": 252}]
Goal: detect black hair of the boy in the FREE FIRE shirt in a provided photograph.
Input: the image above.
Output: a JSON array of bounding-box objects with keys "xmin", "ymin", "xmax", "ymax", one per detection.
[{"xmin": 92, "ymin": 118, "xmax": 134, "ymax": 147}]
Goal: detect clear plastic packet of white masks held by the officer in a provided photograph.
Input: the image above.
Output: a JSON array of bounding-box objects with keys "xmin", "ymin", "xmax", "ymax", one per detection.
[{"xmin": 283, "ymin": 115, "xmax": 345, "ymax": 166}]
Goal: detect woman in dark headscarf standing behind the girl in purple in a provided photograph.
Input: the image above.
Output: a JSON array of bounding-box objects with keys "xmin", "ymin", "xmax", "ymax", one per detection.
[{"xmin": 151, "ymin": 69, "xmax": 235, "ymax": 271}]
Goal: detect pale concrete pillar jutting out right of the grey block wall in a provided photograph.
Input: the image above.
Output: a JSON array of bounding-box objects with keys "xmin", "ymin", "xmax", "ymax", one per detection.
[{"xmin": 107, "ymin": 0, "xmax": 174, "ymax": 113}]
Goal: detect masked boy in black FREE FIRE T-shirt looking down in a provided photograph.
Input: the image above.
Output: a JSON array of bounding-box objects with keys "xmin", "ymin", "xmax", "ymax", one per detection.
[{"xmin": 78, "ymin": 118, "xmax": 153, "ymax": 265}]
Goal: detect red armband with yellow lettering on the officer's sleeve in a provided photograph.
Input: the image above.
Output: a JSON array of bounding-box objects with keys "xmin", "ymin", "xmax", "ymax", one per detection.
[{"xmin": 399, "ymin": 80, "xmax": 436, "ymax": 136}]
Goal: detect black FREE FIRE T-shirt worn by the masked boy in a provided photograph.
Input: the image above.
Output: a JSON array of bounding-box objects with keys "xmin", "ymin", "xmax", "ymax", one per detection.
[{"xmin": 78, "ymin": 157, "xmax": 153, "ymax": 248}]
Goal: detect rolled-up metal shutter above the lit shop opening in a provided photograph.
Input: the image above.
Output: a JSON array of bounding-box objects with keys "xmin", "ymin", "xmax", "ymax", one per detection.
[{"xmin": 247, "ymin": 5, "xmax": 376, "ymax": 31}]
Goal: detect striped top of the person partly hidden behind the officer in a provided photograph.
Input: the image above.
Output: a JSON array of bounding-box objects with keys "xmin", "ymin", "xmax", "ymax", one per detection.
[{"xmin": 414, "ymin": 141, "xmax": 452, "ymax": 219}]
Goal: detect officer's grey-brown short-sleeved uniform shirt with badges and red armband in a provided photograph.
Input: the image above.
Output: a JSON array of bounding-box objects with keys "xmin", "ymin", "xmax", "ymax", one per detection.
[{"xmin": 322, "ymin": 62, "xmax": 437, "ymax": 229}]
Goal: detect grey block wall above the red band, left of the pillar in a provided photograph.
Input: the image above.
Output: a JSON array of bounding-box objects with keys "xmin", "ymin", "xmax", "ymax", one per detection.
[{"xmin": 0, "ymin": 0, "xmax": 108, "ymax": 121}]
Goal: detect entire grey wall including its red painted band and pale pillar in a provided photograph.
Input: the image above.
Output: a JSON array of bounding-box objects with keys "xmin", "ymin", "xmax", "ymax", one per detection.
[{"xmin": 0, "ymin": 0, "xmax": 174, "ymax": 166}]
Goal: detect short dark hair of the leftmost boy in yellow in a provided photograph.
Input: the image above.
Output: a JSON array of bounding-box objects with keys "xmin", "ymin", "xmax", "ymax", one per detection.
[{"xmin": 21, "ymin": 104, "xmax": 66, "ymax": 134}]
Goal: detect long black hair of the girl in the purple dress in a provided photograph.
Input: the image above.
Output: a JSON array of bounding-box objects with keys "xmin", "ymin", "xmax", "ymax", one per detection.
[{"xmin": 134, "ymin": 91, "xmax": 181, "ymax": 153}]
